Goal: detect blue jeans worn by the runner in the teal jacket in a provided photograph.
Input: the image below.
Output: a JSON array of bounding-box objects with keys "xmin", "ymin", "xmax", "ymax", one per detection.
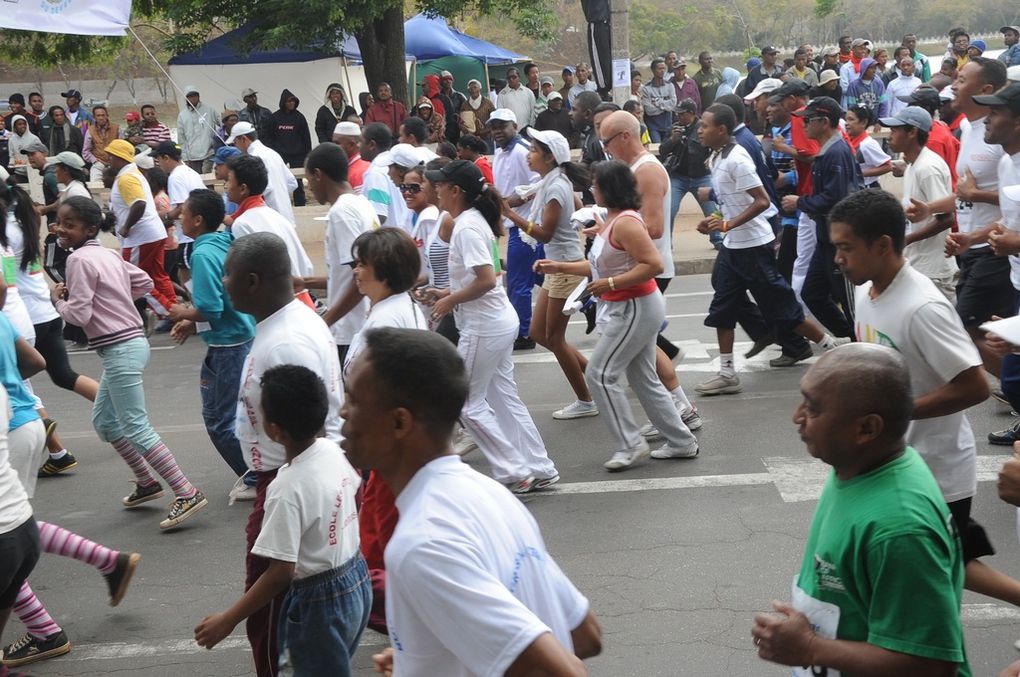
[{"xmin": 199, "ymin": 341, "xmax": 254, "ymax": 484}]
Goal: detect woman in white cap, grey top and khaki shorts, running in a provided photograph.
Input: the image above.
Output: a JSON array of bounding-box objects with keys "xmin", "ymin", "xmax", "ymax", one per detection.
[{"xmin": 503, "ymin": 127, "xmax": 599, "ymax": 420}]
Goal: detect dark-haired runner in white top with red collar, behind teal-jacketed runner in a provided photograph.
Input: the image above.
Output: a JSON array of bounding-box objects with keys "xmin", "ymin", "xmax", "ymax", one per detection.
[{"xmin": 223, "ymin": 155, "xmax": 312, "ymax": 278}]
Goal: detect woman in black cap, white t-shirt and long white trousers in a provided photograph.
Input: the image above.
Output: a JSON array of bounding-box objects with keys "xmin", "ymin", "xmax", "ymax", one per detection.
[{"xmin": 425, "ymin": 160, "xmax": 560, "ymax": 493}]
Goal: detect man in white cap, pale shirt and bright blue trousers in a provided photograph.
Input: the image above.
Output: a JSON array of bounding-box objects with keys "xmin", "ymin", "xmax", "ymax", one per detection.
[{"xmin": 488, "ymin": 109, "xmax": 545, "ymax": 350}]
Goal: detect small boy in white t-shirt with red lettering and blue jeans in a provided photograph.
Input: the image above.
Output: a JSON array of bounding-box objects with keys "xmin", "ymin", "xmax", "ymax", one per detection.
[{"xmin": 195, "ymin": 364, "xmax": 372, "ymax": 676}]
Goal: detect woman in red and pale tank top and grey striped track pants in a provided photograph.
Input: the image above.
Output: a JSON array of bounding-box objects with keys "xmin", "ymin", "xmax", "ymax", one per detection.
[{"xmin": 534, "ymin": 160, "xmax": 699, "ymax": 472}]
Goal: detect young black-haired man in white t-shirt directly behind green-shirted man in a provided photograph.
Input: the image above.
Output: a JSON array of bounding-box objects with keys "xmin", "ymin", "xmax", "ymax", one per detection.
[{"xmin": 829, "ymin": 189, "xmax": 1020, "ymax": 604}]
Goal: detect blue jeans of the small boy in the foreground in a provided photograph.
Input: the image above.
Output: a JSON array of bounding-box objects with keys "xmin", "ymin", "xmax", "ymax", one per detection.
[{"xmin": 279, "ymin": 553, "xmax": 372, "ymax": 677}]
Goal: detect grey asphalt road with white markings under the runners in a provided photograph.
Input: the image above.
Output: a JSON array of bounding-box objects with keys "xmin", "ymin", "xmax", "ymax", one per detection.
[{"xmin": 13, "ymin": 275, "xmax": 1020, "ymax": 677}]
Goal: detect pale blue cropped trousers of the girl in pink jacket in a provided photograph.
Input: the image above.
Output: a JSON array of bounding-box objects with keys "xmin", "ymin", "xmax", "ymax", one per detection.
[{"xmin": 92, "ymin": 336, "xmax": 159, "ymax": 456}]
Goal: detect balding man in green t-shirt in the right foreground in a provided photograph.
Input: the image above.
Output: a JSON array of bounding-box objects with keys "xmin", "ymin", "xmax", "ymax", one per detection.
[{"xmin": 751, "ymin": 344, "xmax": 971, "ymax": 677}]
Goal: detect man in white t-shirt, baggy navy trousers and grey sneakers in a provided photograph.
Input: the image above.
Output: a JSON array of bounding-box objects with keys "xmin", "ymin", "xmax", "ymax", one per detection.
[{"xmin": 695, "ymin": 104, "xmax": 849, "ymax": 395}]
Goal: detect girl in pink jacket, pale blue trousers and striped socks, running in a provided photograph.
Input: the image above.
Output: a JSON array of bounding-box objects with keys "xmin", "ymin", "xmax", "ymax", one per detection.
[{"xmin": 52, "ymin": 198, "xmax": 208, "ymax": 529}]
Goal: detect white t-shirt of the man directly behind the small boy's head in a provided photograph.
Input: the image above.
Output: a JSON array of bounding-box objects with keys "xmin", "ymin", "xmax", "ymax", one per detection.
[{"xmin": 235, "ymin": 299, "xmax": 344, "ymax": 472}]
